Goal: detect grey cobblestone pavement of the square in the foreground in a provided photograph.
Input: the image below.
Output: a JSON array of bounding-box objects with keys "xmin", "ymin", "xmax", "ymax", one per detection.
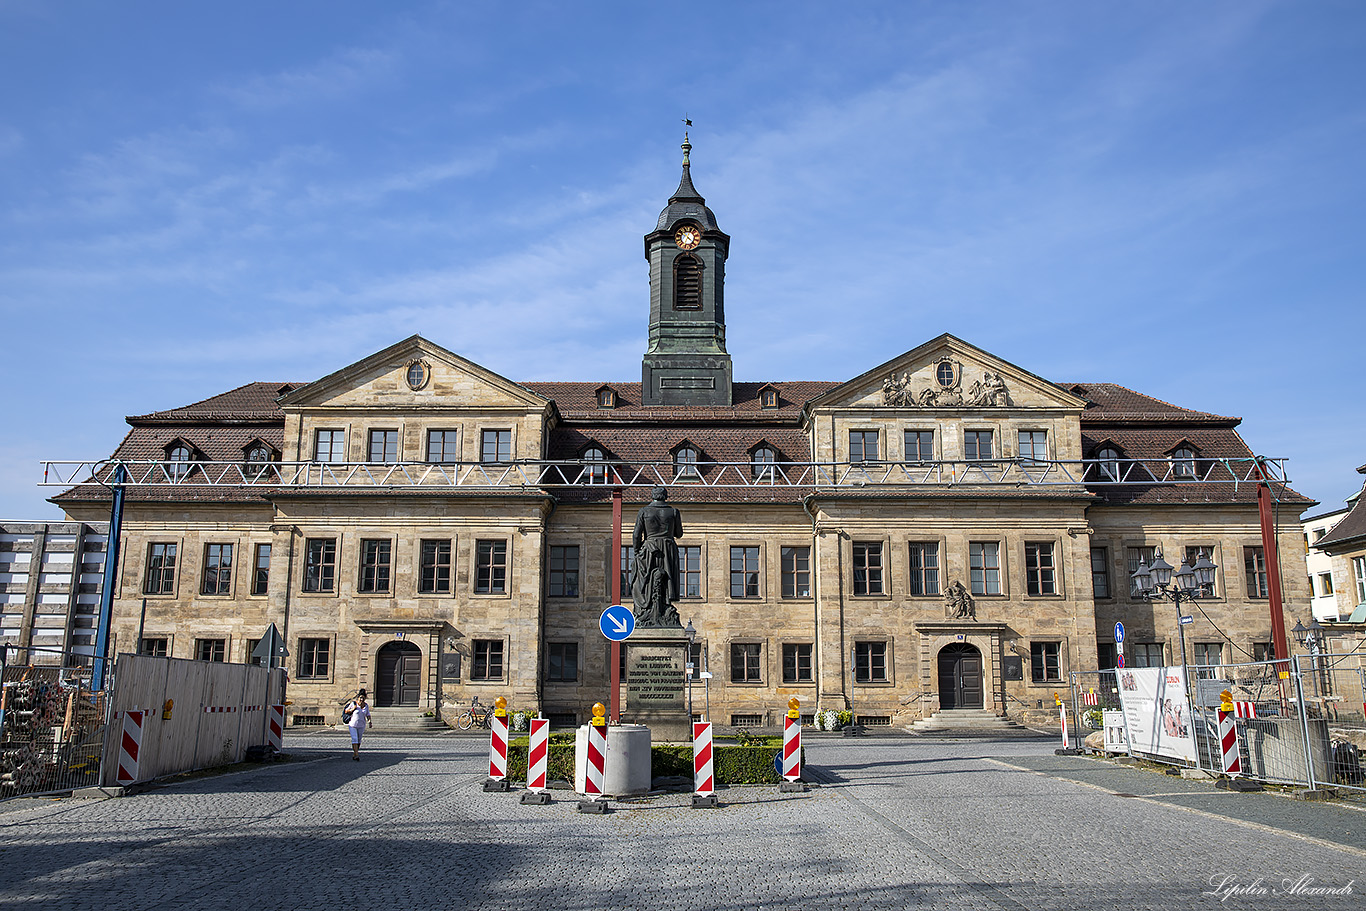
[{"xmin": 0, "ymin": 733, "xmax": 1366, "ymax": 911}]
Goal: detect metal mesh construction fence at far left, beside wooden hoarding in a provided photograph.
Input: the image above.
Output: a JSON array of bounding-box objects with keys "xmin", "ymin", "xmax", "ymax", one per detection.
[{"xmin": 0, "ymin": 649, "xmax": 107, "ymax": 799}]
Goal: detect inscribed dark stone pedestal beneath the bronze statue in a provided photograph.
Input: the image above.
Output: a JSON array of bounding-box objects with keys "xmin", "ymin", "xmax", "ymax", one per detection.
[{"xmin": 622, "ymin": 628, "xmax": 693, "ymax": 743}]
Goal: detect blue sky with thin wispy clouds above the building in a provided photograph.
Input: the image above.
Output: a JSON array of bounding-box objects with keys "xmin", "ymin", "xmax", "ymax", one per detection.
[{"xmin": 0, "ymin": 0, "xmax": 1366, "ymax": 519}]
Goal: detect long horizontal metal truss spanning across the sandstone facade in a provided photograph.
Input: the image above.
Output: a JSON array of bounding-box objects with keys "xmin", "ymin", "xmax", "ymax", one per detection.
[{"xmin": 40, "ymin": 456, "xmax": 1290, "ymax": 490}]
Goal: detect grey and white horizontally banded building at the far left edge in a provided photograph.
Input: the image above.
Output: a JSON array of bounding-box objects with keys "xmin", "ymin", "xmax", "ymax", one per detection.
[{"xmin": 0, "ymin": 522, "xmax": 109, "ymax": 664}]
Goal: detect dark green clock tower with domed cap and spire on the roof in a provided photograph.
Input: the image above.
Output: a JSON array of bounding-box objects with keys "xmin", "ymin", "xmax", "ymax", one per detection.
[{"xmin": 641, "ymin": 134, "xmax": 731, "ymax": 406}]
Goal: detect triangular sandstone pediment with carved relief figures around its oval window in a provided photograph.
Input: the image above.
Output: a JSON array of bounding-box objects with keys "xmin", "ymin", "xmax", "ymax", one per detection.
[{"xmin": 806, "ymin": 333, "xmax": 1086, "ymax": 411}]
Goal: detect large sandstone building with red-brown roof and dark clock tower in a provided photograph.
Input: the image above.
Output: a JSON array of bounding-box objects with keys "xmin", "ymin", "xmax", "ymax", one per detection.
[{"xmin": 53, "ymin": 145, "xmax": 1313, "ymax": 724}]
